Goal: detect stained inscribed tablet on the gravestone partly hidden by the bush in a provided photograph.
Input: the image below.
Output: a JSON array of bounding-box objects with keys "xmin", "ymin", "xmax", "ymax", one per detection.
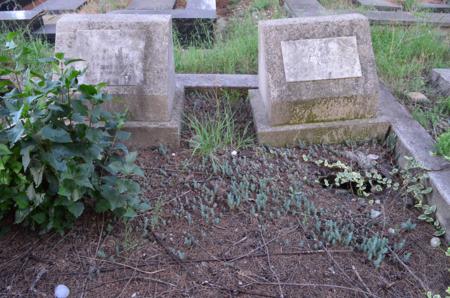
[{"xmin": 75, "ymin": 30, "xmax": 145, "ymax": 86}]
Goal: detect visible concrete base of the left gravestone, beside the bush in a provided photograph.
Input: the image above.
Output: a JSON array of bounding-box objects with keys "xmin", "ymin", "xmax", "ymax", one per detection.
[{"xmin": 124, "ymin": 86, "xmax": 184, "ymax": 149}]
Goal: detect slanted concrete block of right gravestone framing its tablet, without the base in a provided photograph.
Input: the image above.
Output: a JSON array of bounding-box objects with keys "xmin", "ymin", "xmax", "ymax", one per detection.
[{"xmin": 258, "ymin": 14, "xmax": 378, "ymax": 126}]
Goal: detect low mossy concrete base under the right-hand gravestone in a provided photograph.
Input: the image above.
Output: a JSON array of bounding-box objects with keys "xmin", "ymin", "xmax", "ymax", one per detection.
[{"xmin": 249, "ymin": 90, "xmax": 390, "ymax": 146}]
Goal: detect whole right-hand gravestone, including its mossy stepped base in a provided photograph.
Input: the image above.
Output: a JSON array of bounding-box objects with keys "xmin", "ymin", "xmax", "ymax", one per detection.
[{"xmin": 252, "ymin": 14, "xmax": 388, "ymax": 144}]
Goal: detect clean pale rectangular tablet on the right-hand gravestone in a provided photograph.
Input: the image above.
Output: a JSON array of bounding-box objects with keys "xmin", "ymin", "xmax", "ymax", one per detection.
[{"xmin": 281, "ymin": 36, "xmax": 362, "ymax": 82}]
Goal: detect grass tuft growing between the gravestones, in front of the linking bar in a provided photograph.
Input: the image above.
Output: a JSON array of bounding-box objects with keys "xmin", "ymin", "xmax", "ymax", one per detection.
[{"xmin": 188, "ymin": 107, "xmax": 253, "ymax": 157}]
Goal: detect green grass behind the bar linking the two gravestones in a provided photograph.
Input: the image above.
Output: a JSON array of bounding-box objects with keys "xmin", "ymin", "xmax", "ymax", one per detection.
[{"xmin": 175, "ymin": 0, "xmax": 282, "ymax": 74}]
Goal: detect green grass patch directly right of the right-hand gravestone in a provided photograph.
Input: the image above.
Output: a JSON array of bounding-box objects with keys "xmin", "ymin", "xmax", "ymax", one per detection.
[{"xmin": 372, "ymin": 25, "xmax": 450, "ymax": 96}]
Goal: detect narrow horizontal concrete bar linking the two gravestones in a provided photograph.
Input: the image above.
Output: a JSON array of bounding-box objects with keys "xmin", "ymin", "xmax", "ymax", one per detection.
[{"xmin": 176, "ymin": 74, "xmax": 258, "ymax": 89}]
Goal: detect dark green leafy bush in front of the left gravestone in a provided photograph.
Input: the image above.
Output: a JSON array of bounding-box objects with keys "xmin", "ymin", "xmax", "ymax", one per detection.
[{"xmin": 0, "ymin": 33, "xmax": 147, "ymax": 232}]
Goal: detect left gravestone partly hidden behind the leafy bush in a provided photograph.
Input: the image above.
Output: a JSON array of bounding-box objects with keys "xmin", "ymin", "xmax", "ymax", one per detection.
[{"xmin": 55, "ymin": 14, "xmax": 179, "ymax": 145}]
